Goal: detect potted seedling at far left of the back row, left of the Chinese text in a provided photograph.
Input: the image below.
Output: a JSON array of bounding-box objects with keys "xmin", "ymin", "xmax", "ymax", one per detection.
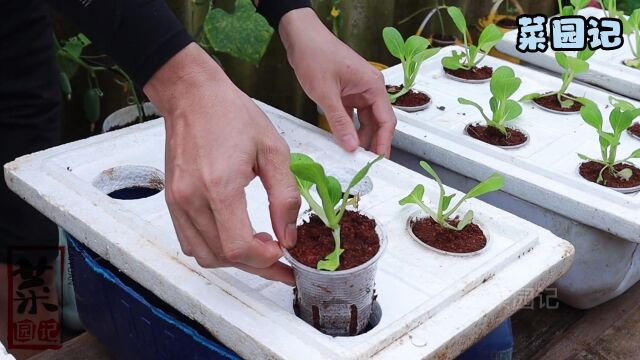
[{"xmin": 442, "ymin": 6, "xmax": 504, "ymax": 83}]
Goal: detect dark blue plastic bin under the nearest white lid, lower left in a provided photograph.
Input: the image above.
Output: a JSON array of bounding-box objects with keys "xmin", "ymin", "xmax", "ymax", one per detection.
[{"xmin": 67, "ymin": 234, "xmax": 240, "ymax": 360}]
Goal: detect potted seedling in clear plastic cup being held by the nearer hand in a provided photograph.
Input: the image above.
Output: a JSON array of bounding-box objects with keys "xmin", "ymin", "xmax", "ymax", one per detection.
[{"xmin": 284, "ymin": 153, "xmax": 386, "ymax": 336}]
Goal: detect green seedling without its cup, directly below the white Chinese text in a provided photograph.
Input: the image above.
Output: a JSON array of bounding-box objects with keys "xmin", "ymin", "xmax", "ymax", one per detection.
[{"xmin": 520, "ymin": 48, "xmax": 594, "ymax": 109}]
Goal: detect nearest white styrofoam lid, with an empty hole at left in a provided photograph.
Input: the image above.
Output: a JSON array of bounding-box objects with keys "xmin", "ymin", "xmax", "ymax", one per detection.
[{"xmin": 5, "ymin": 104, "xmax": 573, "ymax": 359}]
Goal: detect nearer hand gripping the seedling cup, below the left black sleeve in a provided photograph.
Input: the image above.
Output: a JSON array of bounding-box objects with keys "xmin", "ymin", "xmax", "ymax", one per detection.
[{"xmin": 144, "ymin": 44, "xmax": 300, "ymax": 285}]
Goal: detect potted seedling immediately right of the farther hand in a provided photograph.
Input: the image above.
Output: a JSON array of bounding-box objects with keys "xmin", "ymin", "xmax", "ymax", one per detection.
[{"xmin": 382, "ymin": 27, "xmax": 440, "ymax": 112}]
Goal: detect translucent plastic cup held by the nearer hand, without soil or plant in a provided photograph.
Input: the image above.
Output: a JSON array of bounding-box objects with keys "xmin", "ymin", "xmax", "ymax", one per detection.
[{"xmin": 284, "ymin": 217, "xmax": 387, "ymax": 336}]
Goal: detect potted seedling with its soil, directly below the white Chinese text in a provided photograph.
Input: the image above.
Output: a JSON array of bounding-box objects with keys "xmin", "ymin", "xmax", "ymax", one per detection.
[{"xmin": 520, "ymin": 48, "xmax": 594, "ymax": 114}]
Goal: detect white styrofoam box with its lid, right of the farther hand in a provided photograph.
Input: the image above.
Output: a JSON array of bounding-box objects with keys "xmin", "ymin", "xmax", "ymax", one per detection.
[{"xmin": 384, "ymin": 48, "xmax": 640, "ymax": 307}]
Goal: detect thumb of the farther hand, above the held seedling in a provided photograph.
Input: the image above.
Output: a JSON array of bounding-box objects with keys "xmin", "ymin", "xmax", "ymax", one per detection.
[{"xmin": 319, "ymin": 98, "xmax": 360, "ymax": 151}]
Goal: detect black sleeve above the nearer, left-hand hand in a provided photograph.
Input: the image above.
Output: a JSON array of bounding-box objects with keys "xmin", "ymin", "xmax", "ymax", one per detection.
[{"xmin": 48, "ymin": 0, "xmax": 193, "ymax": 87}]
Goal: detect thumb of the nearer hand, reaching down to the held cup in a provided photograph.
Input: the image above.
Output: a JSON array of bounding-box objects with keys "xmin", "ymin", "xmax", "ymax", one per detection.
[{"xmin": 257, "ymin": 137, "xmax": 301, "ymax": 249}]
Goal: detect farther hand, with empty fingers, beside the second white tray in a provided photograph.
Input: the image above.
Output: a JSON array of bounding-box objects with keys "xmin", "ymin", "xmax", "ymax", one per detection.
[{"xmin": 279, "ymin": 8, "xmax": 396, "ymax": 157}]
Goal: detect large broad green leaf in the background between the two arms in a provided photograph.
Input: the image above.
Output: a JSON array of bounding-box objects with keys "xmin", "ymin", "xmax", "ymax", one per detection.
[{"xmin": 204, "ymin": 0, "xmax": 273, "ymax": 64}]
